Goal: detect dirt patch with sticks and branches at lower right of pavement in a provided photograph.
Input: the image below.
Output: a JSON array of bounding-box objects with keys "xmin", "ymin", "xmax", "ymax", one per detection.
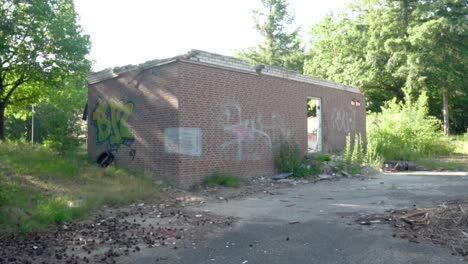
[{"xmin": 356, "ymin": 201, "xmax": 468, "ymax": 259}]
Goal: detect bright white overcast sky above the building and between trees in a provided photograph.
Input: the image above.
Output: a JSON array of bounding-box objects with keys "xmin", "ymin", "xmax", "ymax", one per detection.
[{"xmin": 75, "ymin": 0, "xmax": 350, "ymax": 71}]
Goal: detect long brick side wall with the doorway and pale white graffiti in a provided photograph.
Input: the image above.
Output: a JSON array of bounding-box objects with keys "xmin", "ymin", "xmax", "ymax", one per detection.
[{"xmin": 178, "ymin": 62, "xmax": 365, "ymax": 186}]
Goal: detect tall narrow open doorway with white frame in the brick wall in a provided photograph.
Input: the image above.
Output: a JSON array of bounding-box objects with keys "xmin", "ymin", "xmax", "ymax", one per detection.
[{"xmin": 307, "ymin": 97, "xmax": 322, "ymax": 153}]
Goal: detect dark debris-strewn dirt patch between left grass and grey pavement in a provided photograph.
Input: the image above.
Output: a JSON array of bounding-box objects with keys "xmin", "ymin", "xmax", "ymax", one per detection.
[{"xmin": 0, "ymin": 198, "xmax": 236, "ymax": 264}]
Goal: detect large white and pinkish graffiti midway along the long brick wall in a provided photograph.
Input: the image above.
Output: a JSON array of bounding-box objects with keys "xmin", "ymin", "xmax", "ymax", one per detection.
[{"xmin": 221, "ymin": 103, "xmax": 290, "ymax": 160}]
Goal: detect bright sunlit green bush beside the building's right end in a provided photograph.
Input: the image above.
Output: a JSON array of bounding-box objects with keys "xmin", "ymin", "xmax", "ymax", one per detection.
[{"xmin": 366, "ymin": 92, "xmax": 454, "ymax": 162}]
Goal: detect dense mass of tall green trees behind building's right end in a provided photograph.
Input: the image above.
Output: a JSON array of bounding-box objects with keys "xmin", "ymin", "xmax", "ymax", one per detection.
[{"xmin": 305, "ymin": 0, "xmax": 468, "ymax": 133}]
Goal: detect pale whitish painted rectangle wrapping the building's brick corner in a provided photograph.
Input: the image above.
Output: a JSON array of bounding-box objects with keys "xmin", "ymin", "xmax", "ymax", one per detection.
[{"xmin": 164, "ymin": 127, "xmax": 202, "ymax": 156}]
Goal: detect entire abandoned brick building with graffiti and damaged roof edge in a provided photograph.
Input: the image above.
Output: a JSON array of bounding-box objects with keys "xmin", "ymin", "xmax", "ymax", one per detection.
[{"xmin": 87, "ymin": 50, "xmax": 366, "ymax": 186}]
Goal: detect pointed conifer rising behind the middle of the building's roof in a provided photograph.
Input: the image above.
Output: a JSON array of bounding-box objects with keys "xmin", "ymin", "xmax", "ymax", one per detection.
[{"xmin": 238, "ymin": 0, "xmax": 304, "ymax": 72}]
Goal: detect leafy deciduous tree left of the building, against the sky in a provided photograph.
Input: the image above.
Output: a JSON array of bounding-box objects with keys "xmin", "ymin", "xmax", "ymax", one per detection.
[{"xmin": 0, "ymin": 0, "xmax": 90, "ymax": 141}]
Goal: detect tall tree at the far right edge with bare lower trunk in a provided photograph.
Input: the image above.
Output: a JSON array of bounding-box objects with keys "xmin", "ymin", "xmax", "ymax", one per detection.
[{"xmin": 407, "ymin": 0, "xmax": 468, "ymax": 135}]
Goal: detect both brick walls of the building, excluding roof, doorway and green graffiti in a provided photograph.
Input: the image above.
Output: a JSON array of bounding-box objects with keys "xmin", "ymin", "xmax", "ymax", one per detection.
[{"xmin": 88, "ymin": 62, "xmax": 365, "ymax": 186}]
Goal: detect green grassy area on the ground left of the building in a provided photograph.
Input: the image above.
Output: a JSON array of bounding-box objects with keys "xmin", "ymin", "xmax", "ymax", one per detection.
[{"xmin": 0, "ymin": 143, "xmax": 158, "ymax": 232}]
